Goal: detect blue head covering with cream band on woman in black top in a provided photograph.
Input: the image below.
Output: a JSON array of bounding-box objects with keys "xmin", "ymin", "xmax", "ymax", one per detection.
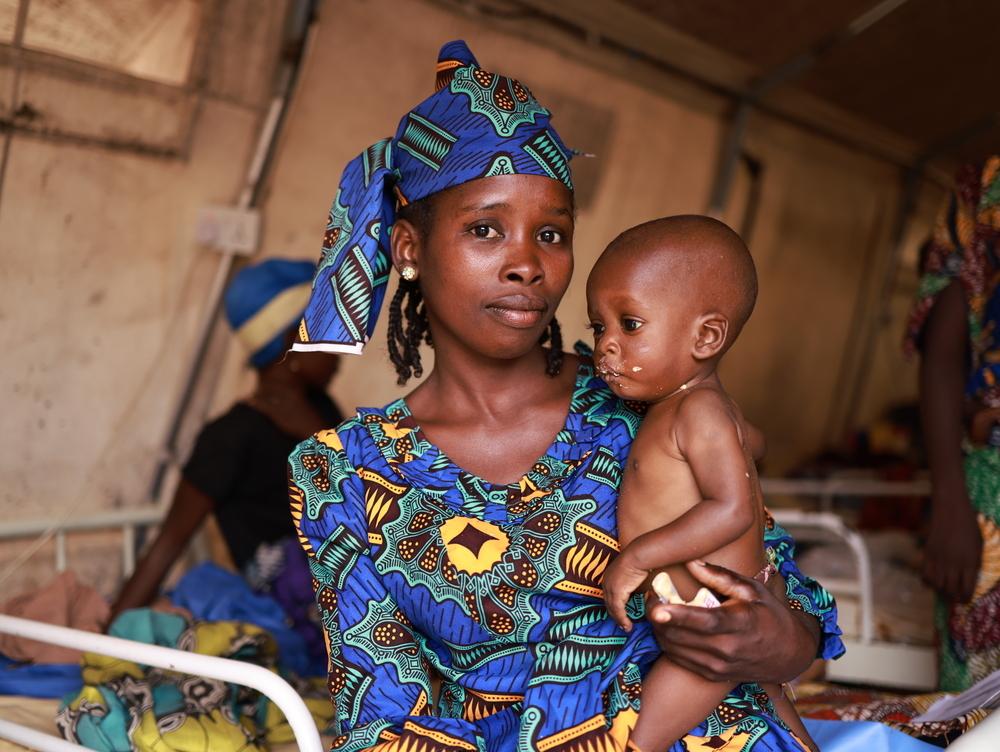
[{"xmin": 223, "ymin": 259, "xmax": 316, "ymax": 368}]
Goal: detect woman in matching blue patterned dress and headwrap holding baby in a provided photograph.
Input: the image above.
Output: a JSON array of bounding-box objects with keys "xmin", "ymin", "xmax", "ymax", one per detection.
[{"xmin": 289, "ymin": 42, "xmax": 840, "ymax": 752}]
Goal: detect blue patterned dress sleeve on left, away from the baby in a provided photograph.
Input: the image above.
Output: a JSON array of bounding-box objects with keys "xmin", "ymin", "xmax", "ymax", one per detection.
[{"xmin": 289, "ymin": 424, "xmax": 482, "ymax": 752}]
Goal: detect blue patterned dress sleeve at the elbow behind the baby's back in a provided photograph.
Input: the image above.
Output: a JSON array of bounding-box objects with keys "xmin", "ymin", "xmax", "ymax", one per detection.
[{"xmin": 764, "ymin": 516, "xmax": 846, "ymax": 659}]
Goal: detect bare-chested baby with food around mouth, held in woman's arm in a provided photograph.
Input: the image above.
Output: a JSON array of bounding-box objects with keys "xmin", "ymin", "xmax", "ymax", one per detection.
[{"xmin": 587, "ymin": 216, "xmax": 812, "ymax": 752}]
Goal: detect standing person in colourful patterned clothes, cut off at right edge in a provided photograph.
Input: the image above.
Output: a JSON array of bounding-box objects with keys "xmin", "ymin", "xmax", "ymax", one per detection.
[{"xmin": 907, "ymin": 155, "xmax": 1000, "ymax": 692}]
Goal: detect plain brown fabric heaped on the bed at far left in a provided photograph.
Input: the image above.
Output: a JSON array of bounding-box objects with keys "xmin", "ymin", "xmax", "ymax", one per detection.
[{"xmin": 0, "ymin": 572, "xmax": 111, "ymax": 663}]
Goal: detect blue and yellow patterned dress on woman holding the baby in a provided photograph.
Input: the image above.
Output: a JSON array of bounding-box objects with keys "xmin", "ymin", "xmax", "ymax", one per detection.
[{"xmin": 290, "ymin": 360, "xmax": 843, "ymax": 752}]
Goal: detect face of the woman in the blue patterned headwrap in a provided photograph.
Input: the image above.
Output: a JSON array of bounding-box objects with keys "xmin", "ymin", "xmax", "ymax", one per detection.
[{"xmin": 393, "ymin": 175, "xmax": 573, "ymax": 359}]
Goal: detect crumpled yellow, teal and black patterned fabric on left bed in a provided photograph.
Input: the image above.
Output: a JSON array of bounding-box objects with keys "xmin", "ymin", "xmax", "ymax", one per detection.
[{"xmin": 56, "ymin": 609, "xmax": 333, "ymax": 752}]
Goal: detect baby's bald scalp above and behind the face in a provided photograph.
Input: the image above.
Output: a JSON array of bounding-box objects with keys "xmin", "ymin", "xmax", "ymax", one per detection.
[{"xmin": 592, "ymin": 214, "xmax": 757, "ymax": 349}]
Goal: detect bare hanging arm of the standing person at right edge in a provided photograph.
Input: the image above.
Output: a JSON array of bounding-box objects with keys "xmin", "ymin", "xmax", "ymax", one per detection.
[{"xmin": 920, "ymin": 281, "xmax": 983, "ymax": 603}]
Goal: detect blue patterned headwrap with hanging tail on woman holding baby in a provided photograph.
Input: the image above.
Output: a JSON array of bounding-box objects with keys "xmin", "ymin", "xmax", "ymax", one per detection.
[{"xmin": 293, "ymin": 41, "xmax": 573, "ymax": 353}]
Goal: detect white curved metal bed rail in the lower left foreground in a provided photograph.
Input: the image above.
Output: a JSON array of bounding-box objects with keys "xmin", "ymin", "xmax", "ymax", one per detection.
[{"xmin": 0, "ymin": 614, "xmax": 324, "ymax": 752}]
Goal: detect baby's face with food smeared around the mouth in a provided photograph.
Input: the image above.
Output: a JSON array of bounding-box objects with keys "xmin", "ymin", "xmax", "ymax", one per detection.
[{"xmin": 587, "ymin": 255, "xmax": 696, "ymax": 402}]
